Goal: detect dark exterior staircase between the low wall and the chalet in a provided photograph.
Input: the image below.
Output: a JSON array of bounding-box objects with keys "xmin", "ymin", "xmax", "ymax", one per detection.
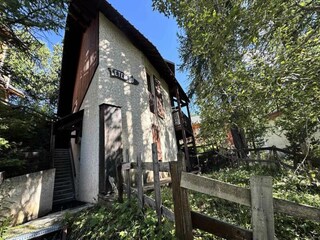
[{"xmin": 53, "ymin": 148, "xmax": 75, "ymax": 205}]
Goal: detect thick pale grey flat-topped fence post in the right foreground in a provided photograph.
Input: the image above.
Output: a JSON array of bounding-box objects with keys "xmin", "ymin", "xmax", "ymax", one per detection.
[{"xmin": 250, "ymin": 176, "xmax": 274, "ymax": 240}]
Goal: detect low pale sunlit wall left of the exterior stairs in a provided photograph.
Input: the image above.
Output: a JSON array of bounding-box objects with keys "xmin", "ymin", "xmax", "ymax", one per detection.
[{"xmin": 0, "ymin": 169, "xmax": 55, "ymax": 225}]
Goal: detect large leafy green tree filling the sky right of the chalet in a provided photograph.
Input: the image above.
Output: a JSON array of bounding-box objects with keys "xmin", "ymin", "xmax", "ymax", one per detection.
[{"xmin": 153, "ymin": 0, "xmax": 320, "ymax": 150}]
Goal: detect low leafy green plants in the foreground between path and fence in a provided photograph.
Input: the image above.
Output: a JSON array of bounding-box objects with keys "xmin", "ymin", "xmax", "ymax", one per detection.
[{"xmin": 66, "ymin": 200, "xmax": 174, "ymax": 239}]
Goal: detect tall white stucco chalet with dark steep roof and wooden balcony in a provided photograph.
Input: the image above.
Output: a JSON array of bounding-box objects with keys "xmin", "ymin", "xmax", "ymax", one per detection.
[{"xmin": 53, "ymin": 0, "xmax": 194, "ymax": 204}]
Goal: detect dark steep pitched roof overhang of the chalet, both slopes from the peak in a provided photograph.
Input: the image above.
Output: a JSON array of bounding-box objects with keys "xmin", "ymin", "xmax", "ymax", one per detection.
[{"xmin": 58, "ymin": 0, "xmax": 189, "ymax": 116}]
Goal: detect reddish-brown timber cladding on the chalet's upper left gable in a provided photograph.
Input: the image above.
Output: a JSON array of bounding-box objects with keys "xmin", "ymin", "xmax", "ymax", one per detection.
[{"xmin": 72, "ymin": 15, "xmax": 99, "ymax": 112}]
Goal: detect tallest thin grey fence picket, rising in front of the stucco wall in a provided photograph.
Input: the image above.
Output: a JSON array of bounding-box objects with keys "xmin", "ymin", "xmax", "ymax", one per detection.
[{"xmin": 152, "ymin": 143, "xmax": 161, "ymax": 226}]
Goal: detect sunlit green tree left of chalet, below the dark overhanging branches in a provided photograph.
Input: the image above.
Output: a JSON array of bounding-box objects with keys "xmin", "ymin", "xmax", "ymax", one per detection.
[{"xmin": 0, "ymin": 42, "xmax": 62, "ymax": 154}]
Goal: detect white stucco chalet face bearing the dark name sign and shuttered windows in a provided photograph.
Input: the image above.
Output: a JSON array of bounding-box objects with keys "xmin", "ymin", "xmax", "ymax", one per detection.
[{"xmin": 98, "ymin": 14, "xmax": 177, "ymax": 161}]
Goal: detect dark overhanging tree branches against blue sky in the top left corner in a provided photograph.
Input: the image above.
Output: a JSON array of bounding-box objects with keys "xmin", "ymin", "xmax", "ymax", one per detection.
[{"xmin": 0, "ymin": 0, "xmax": 67, "ymax": 54}]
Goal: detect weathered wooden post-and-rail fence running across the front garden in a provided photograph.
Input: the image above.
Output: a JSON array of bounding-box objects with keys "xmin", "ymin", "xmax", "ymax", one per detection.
[{"xmin": 119, "ymin": 144, "xmax": 320, "ymax": 240}]
